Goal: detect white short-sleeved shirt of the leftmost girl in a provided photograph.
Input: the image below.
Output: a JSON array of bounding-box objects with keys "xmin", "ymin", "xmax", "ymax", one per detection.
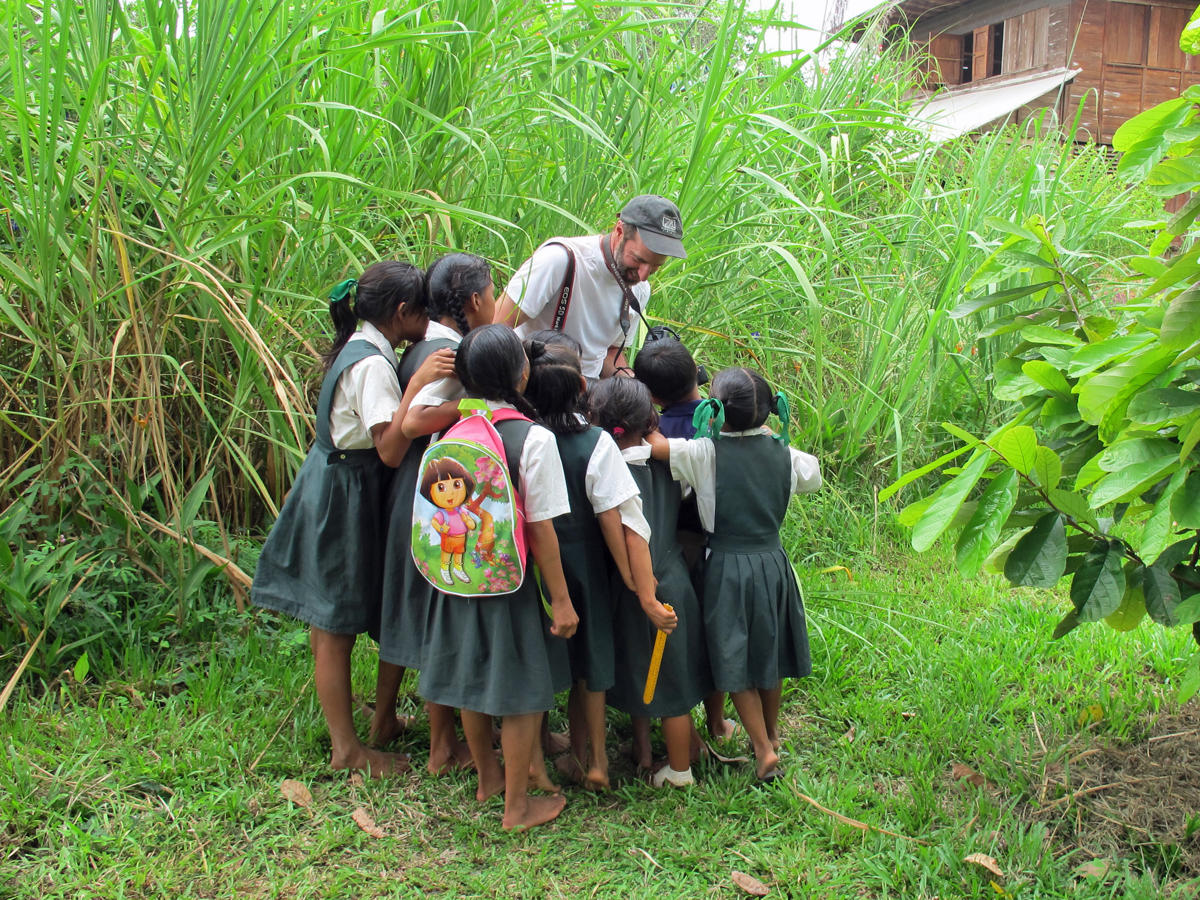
[{"xmin": 329, "ymin": 322, "xmax": 403, "ymax": 450}]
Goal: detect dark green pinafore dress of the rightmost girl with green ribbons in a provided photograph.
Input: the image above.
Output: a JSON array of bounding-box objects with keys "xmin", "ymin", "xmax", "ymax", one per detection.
[{"xmin": 701, "ymin": 434, "xmax": 812, "ymax": 691}]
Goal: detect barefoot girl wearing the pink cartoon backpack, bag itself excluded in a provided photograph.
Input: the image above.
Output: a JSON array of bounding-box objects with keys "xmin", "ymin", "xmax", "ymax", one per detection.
[{"xmin": 418, "ymin": 325, "xmax": 578, "ymax": 829}]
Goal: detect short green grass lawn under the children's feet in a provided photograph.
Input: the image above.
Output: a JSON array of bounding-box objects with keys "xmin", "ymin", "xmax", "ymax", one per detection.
[{"xmin": 0, "ymin": 554, "xmax": 1195, "ymax": 900}]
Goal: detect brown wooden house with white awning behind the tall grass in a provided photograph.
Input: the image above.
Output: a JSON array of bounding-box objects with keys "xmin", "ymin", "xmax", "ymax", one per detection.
[{"xmin": 892, "ymin": 0, "xmax": 1200, "ymax": 144}]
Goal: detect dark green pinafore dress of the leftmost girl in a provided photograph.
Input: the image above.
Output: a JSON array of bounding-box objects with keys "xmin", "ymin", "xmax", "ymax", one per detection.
[{"xmin": 251, "ymin": 341, "xmax": 392, "ymax": 636}]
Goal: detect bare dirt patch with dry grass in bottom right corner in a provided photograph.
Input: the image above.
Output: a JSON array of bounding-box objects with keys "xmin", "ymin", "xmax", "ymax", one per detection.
[{"xmin": 1030, "ymin": 702, "xmax": 1200, "ymax": 880}]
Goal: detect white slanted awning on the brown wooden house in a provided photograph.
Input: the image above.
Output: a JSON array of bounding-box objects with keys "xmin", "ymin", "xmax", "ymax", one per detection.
[{"xmin": 908, "ymin": 68, "xmax": 1082, "ymax": 144}]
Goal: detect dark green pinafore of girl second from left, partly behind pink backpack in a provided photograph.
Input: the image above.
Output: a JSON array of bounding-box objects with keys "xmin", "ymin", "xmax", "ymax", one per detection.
[{"xmin": 379, "ymin": 337, "xmax": 456, "ymax": 668}]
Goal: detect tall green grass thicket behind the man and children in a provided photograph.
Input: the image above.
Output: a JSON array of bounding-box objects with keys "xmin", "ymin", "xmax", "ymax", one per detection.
[{"xmin": 0, "ymin": 0, "xmax": 1142, "ymax": 676}]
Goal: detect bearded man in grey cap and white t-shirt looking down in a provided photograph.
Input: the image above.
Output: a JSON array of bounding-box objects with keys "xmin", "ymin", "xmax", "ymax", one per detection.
[{"xmin": 494, "ymin": 194, "xmax": 688, "ymax": 379}]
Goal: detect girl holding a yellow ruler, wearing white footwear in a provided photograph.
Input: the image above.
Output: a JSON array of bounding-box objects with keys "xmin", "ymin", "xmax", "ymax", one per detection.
[{"xmin": 588, "ymin": 378, "xmax": 712, "ymax": 787}]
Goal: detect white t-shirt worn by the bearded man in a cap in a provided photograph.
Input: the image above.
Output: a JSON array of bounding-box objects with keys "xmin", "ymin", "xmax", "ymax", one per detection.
[{"xmin": 504, "ymin": 234, "xmax": 650, "ymax": 378}]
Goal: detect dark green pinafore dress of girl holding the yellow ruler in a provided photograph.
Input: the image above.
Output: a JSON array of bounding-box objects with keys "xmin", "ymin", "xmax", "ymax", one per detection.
[{"xmin": 608, "ymin": 460, "xmax": 713, "ymax": 719}]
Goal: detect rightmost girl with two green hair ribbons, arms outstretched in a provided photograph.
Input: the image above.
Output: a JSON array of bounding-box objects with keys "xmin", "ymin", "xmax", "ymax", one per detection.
[{"xmin": 653, "ymin": 368, "xmax": 821, "ymax": 781}]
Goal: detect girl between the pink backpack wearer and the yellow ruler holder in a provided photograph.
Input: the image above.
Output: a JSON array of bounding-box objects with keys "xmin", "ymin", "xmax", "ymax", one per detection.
[{"xmin": 524, "ymin": 340, "xmax": 649, "ymax": 790}]
